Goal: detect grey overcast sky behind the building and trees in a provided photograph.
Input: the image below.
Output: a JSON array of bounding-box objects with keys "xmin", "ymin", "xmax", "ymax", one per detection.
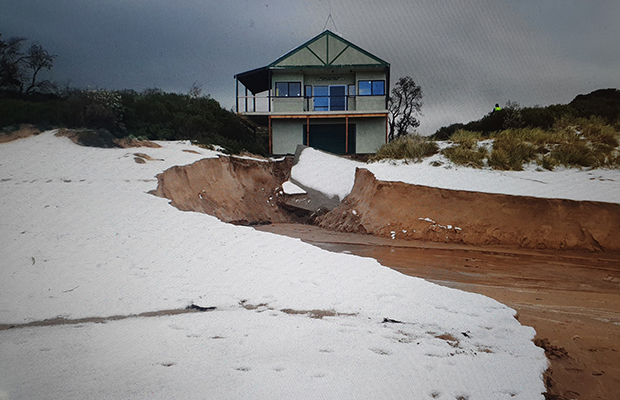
[{"xmin": 0, "ymin": 0, "xmax": 620, "ymax": 134}]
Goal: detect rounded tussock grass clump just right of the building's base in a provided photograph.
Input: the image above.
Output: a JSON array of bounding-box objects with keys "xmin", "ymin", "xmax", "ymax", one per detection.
[{"xmin": 370, "ymin": 134, "xmax": 439, "ymax": 162}]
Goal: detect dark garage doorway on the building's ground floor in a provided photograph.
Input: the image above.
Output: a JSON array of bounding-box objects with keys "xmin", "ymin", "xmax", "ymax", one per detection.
[{"xmin": 303, "ymin": 124, "xmax": 355, "ymax": 154}]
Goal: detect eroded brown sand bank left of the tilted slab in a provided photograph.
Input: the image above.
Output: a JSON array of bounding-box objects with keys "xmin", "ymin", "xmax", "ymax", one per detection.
[{"xmin": 151, "ymin": 156, "xmax": 295, "ymax": 225}]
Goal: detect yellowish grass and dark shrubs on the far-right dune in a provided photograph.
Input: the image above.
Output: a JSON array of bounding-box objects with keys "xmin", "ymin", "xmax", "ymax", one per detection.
[{"xmin": 432, "ymin": 89, "xmax": 620, "ymax": 171}]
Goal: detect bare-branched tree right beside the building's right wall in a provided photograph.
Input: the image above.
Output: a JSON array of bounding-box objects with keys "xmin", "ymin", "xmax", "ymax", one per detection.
[{"xmin": 388, "ymin": 76, "xmax": 422, "ymax": 141}]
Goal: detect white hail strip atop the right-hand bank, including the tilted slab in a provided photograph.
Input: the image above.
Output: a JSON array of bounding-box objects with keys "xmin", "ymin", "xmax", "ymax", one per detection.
[{"xmin": 291, "ymin": 146, "xmax": 620, "ymax": 203}]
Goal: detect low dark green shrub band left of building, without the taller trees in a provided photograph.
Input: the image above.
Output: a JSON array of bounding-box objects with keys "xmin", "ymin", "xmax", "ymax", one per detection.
[{"xmin": 0, "ymin": 89, "xmax": 268, "ymax": 155}]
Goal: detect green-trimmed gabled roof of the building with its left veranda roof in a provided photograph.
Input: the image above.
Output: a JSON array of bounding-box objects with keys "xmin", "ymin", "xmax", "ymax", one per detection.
[{"xmin": 235, "ymin": 30, "xmax": 390, "ymax": 94}]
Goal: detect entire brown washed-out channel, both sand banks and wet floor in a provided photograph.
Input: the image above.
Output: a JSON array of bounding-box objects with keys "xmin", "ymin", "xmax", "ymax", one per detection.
[{"xmin": 152, "ymin": 156, "xmax": 620, "ymax": 399}]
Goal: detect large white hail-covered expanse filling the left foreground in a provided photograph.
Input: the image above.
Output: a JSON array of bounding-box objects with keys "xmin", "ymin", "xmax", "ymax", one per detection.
[{"xmin": 0, "ymin": 132, "xmax": 547, "ymax": 400}]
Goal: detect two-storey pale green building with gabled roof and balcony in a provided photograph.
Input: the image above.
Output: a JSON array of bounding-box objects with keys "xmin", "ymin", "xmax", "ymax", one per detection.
[{"xmin": 235, "ymin": 30, "xmax": 390, "ymax": 154}]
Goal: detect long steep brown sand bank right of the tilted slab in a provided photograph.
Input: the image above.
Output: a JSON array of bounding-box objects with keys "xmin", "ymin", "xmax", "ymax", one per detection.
[{"xmin": 319, "ymin": 169, "xmax": 620, "ymax": 251}]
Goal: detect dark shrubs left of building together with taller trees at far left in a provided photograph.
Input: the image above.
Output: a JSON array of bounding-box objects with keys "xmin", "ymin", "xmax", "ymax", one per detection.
[{"xmin": 0, "ymin": 34, "xmax": 268, "ymax": 155}]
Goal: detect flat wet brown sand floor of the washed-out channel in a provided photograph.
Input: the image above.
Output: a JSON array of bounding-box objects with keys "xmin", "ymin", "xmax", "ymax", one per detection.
[{"xmin": 257, "ymin": 224, "xmax": 620, "ymax": 400}]
